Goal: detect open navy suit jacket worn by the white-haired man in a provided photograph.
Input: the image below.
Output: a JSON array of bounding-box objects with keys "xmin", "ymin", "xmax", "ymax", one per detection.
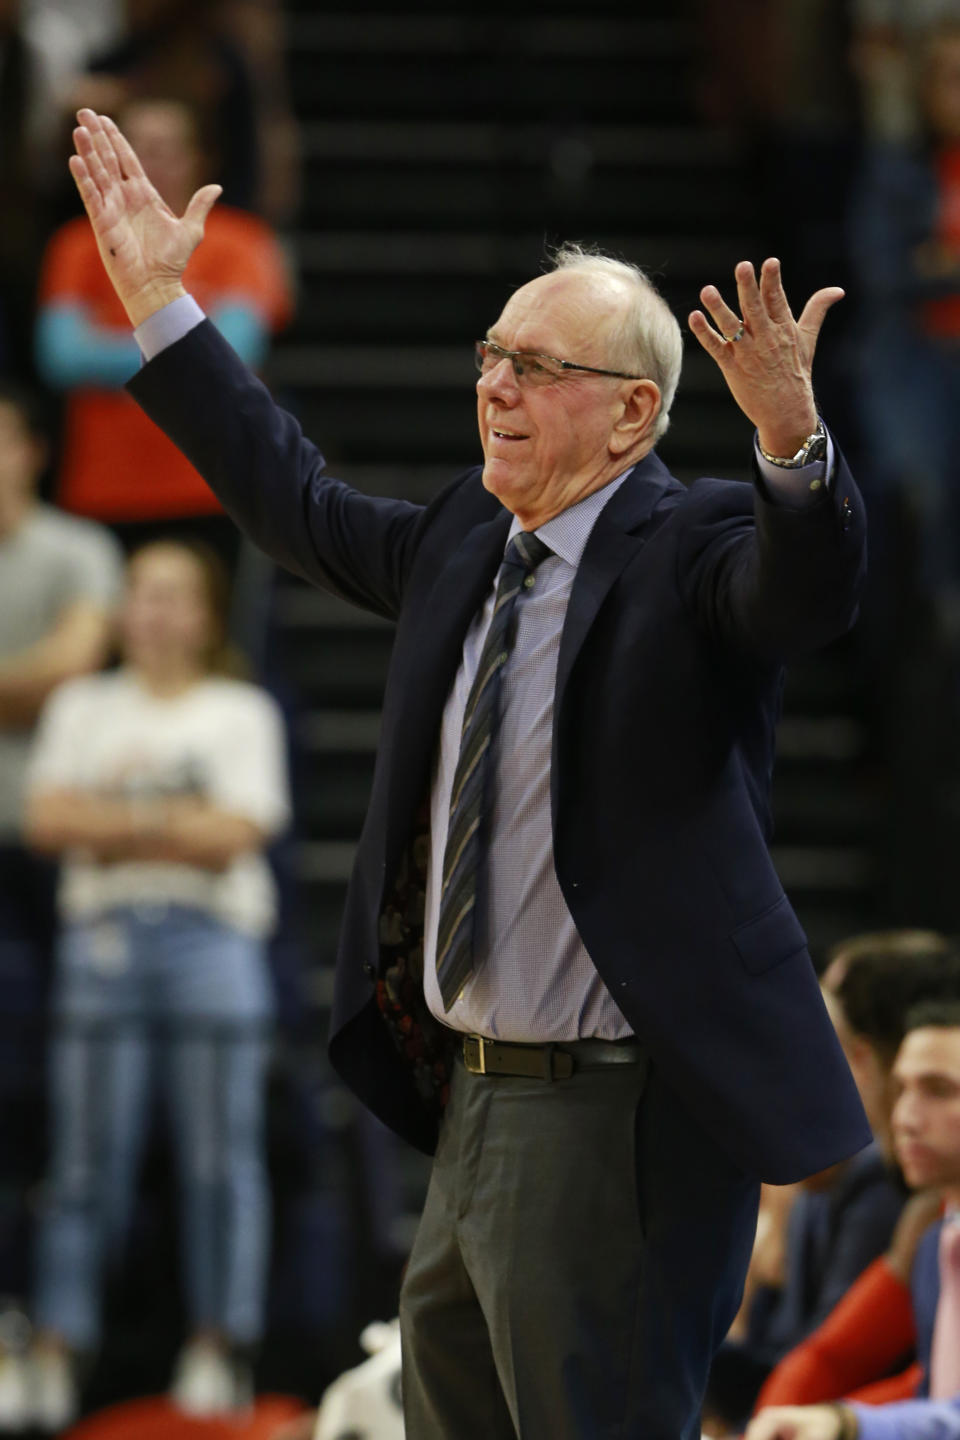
[{"xmin": 130, "ymin": 323, "xmax": 871, "ymax": 1182}]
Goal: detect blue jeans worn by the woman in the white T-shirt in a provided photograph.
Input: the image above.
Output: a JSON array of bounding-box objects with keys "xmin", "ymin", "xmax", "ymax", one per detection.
[{"xmin": 35, "ymin": 906, "xmax": 273, "ymax": 1349}]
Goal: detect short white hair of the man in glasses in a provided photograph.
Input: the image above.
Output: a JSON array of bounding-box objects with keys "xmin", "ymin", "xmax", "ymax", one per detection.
[{"xmin": 550, "ymin": 243, "xmax": 684, "ymax": 441}]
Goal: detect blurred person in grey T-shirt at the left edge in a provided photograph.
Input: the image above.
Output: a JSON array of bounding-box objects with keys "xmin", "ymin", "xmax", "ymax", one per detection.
[{"xmin": 0, "ymin": 382, "xmax": 122, "ymax": 1423}]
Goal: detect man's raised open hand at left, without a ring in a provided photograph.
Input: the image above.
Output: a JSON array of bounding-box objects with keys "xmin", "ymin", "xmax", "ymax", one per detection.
[{"xmin": 71, "ymin": 109, "xmax": 222, "ymax": 327}]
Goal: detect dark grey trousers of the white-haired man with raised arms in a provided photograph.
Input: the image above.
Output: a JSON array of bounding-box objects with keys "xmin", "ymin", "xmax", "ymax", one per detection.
[{"xmin": 400, "ymin": 1063, "xmax": 759, "ymax": 1440}]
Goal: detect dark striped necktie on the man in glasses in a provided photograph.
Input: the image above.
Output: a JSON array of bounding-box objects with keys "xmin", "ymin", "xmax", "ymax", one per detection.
[{"xmin": 436, "ymin": 531, "xmax": 551, "ymax": 1011}]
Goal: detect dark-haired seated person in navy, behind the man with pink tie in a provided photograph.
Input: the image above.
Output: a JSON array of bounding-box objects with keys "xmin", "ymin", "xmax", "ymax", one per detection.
[{"xmin": 704, "ymin": 930, "xmax": 960, "ymax": 1434}]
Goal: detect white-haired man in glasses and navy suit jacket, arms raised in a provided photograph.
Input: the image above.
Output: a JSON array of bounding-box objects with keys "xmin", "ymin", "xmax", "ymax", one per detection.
[{"xmin": 71, "ymin": 111, "xmax": 869, "ymax": 1440}]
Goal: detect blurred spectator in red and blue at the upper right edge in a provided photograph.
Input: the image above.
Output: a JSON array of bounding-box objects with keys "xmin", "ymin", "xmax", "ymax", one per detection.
[{"xmin": 851, "ymin": 17, "xmax": 960, "ymax": 655}]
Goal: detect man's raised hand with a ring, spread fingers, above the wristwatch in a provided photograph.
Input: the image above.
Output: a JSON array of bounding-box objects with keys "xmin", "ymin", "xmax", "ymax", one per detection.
[{"xmin": 689, "ymin": 259, "xmax": 843, "ymax": 458}]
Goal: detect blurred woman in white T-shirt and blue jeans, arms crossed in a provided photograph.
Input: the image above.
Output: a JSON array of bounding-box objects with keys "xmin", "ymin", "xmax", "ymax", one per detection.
[{"xmin": 17, "ymin": 543, "xmax": 288, "ymax": 1430}]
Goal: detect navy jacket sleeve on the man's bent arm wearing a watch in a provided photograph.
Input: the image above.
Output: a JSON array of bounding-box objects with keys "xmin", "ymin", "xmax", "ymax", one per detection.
[{"xmin": 678, "ymin": 434, "xmax": 866, "ymax": 661}]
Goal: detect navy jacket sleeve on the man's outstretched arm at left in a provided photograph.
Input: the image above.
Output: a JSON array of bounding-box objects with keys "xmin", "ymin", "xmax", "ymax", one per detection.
[{"xmin": 128, "ymin": 321, "xmax": 423, "ymax": 619}]
